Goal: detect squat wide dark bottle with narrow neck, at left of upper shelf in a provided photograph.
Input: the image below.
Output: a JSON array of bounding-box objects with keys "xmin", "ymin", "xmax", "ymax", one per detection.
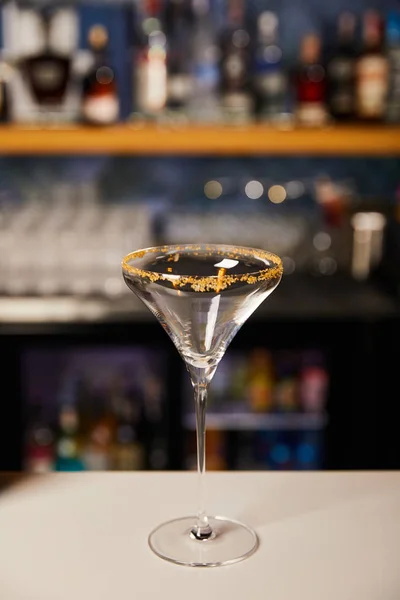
[{"xmin": 21, "ymin": 6, "xmax": 71, "ymax": 109}]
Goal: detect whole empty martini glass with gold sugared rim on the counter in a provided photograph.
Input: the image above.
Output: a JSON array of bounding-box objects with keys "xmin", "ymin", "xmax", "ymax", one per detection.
[{"xmin": 122, "ymin": 244, "xmax": 282, "ymax": 567}]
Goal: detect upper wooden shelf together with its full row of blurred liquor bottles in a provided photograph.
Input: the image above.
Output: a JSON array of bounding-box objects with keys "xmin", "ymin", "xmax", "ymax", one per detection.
[{"xmin": 0, "ymin": 0, "xmax": 400, "ymax": 141}]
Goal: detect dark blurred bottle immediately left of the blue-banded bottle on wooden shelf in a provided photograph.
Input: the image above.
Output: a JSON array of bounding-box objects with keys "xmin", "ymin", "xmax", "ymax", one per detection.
[{"xmin": 220, "ymin": 0, "xmax": 254, "ymax": 123}]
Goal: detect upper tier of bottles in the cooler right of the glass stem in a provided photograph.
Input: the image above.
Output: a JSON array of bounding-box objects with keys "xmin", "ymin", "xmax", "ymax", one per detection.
[{"xmin": 183, "ymin": 347, "xmax": 329, "ymax": 431}]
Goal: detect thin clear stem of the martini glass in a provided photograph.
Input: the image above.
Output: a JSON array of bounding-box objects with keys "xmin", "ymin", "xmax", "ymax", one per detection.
[{"xmin": 191, "ymin": 382, "xmax": 212, "ymax": 540}]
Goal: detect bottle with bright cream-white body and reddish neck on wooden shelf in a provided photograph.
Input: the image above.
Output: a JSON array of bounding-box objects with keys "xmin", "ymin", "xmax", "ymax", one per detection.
[{"xmin": 134, "ymin": 0, "xmax": 167, "ymax": 118}]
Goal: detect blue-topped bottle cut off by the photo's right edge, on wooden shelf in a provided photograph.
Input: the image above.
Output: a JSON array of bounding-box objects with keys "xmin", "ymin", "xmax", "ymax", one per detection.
[{"xmin": 386, "ymin": 11, "xmax": 400, "ymax": 123}]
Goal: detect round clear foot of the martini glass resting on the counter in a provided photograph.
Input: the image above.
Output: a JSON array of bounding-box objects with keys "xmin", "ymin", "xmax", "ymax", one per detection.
[{"xmin": 149, "ymin": 517, "xmax": 258, "ymax": 567}]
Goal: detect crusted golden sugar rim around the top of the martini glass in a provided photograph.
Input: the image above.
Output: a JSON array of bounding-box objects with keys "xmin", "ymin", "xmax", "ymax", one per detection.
[{"xmin": 122, "ymin": 244, "xmax": 283, "ymax": 292}]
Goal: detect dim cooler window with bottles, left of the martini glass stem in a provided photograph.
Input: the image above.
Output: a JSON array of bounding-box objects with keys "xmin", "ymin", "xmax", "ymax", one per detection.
[{"xmin": 22, "ymin": 347, "xmax": 168, "ymax": 473}]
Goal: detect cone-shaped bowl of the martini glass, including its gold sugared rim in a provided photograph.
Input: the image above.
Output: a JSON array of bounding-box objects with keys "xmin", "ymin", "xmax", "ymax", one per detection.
[{"xmin": 123, "ymin": 246, "xmax": 282, "ymax": 372}]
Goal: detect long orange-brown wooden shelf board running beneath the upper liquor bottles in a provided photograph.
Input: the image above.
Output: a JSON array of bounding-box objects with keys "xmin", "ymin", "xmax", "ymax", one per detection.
[{"xmin": 0, "ymin": 125, "xmax": 400, "ymax": 156}]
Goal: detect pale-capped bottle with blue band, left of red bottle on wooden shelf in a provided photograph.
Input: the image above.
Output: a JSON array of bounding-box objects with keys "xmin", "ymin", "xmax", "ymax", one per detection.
[{"xmin": 253, "ymin": 11, "xmax": 287, "ymax": 121}]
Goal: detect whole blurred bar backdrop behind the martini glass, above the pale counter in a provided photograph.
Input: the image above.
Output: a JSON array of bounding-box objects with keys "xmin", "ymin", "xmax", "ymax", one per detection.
[{"xmin": 0, "ymin": 0, "xmax": 400, "ymax": 472}]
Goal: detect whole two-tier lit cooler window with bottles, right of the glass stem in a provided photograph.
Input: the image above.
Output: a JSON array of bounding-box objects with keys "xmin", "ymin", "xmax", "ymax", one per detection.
[{"xmin": 183, "ymin": 347, "xmax": 329, "ymax": 470}]
